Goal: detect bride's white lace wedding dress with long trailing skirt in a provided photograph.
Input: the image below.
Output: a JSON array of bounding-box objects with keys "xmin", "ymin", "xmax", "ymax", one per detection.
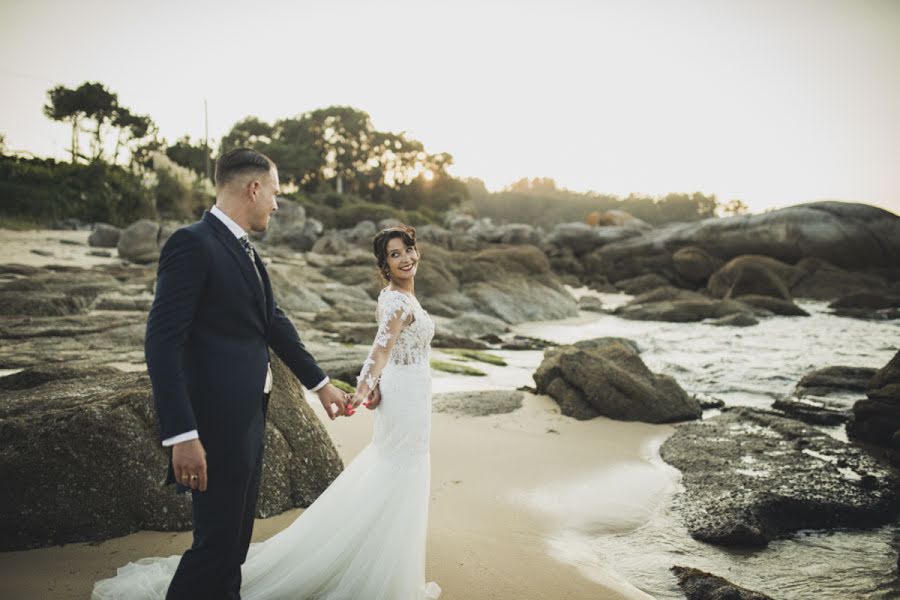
[{"xmin": 92, "ymin": 288, "xmax": 441, "ymax": 600}]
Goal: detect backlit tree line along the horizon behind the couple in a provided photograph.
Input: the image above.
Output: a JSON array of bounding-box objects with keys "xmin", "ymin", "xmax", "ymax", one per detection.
[{"xmin": 0, "ymin": 82, "xmax": 746, "ymax": 227}]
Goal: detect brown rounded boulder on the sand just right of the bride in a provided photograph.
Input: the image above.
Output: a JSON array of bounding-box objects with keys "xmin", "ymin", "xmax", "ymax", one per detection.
[{"xmin": 534, "ymin": 338, "xmax": 702, "ymax": 423}]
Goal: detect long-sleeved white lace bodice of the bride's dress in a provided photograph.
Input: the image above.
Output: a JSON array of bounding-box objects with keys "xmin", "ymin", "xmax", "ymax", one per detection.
[{"xmin": 356, "ymin": 288, "xmax": 434, "ymax": 394}]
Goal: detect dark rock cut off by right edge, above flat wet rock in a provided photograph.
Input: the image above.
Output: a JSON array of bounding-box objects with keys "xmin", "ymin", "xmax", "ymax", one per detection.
[{"xmin": 847, "ymin": 352, "xmax": 900, "ymax": 465}]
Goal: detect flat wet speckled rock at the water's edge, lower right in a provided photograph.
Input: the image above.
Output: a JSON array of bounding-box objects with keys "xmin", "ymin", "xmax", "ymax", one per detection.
[{"xmin": 660, "ymin": 408, "xmax": 900, "ymax": 547}]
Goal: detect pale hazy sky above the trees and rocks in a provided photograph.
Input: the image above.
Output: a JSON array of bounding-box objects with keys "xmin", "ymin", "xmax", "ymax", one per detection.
[{"xmin": 0, "ymin": 0, "xmax": 900, "ymax": 213}]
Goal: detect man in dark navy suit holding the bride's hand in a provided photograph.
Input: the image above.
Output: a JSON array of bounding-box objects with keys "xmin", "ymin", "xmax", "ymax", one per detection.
[{"xmin": 144, "ymin": 148, "xmax": 347, "ymax": 600}]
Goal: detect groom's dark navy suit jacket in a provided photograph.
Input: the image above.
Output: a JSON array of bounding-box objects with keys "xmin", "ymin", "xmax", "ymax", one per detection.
[{"xmin": 144, "ymin": 211, "xmax": 325, "ymax": 466}]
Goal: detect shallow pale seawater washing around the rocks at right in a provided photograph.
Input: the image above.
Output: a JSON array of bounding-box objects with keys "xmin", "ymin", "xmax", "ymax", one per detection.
[{"xmin": 506, "ymin": 290, "xmax": 900, "ymax": 600}]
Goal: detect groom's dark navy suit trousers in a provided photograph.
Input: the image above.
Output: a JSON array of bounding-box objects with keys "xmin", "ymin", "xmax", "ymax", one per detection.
[{"xmin": 166, "ymin": 395, "xmax": 268, "ymax": 600}]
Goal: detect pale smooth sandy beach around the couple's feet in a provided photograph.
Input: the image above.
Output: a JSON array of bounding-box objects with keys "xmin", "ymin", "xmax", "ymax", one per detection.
[{"xmin": 0, "ymin": 395, "xmax": 667, "ymax": 600}]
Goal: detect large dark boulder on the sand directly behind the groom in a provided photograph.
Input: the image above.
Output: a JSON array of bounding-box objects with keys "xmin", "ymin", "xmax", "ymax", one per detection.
[{"xmin": 0, "ymin": 360, "xmax": 343, "ymax": 550}]
